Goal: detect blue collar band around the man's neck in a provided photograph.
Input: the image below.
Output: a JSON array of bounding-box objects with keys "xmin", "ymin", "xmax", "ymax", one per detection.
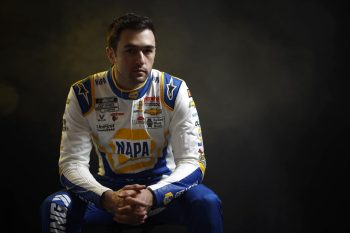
[{"xmin": 107, "ymin": 68, "xmax": 153, "ymax": 100}]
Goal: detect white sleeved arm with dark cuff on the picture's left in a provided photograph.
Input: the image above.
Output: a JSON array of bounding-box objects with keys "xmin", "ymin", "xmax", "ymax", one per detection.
[{"xmin": 59, "ymin": 85, "xmax": 110, "ymax": 205}]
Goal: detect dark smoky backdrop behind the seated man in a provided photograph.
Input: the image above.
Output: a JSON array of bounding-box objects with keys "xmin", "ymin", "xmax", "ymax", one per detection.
[{"xmin": 0, "ymin": 0, "xmax": 349, "ymax": 233}]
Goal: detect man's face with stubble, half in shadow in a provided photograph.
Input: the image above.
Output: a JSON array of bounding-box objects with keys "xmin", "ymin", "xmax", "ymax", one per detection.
[{"xmin": 113, "ymin": 29, "xmax": 156, "ymax": 89}]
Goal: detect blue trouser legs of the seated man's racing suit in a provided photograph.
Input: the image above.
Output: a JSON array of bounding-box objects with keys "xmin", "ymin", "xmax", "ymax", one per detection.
[{"xmin": 41, "ymin": 176, "xmax": 223, "ymax": 233}]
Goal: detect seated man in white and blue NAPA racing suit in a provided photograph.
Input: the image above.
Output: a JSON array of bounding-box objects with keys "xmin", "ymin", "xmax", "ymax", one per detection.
[{"xmin": 41, "ymin": 13, "xmax": 223, "ymax": 233}]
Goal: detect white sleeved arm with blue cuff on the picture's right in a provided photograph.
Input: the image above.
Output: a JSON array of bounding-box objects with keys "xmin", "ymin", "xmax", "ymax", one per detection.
[{"xmin": 149, "ymin": 81, "xmax": 206, "ymax": 207}]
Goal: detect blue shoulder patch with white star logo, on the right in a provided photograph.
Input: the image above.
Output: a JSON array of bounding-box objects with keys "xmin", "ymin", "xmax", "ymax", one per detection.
[{"xmin": 161, "ymin": 73, "xmax": 182, "ymax": 110}]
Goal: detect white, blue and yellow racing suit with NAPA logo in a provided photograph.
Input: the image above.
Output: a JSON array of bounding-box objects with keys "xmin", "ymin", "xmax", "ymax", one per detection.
[{"xmin": 42, "ymin": 69, "xmax": 222, "ymax": 232}]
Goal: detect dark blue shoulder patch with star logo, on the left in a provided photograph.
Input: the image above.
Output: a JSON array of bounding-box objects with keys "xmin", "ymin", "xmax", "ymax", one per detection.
[{"xmin": 72, "ymin": 76, "xmax": 94, "ymax": 115}]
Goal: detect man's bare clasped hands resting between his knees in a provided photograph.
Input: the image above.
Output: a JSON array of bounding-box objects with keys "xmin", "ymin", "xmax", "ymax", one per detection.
[{"xmin": 101, "ymin": 184, "xmax": 153, "ymax": 225}]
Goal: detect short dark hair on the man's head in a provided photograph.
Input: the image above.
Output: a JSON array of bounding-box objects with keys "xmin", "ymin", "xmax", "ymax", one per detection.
[{"xmin": 107, "ymin": 13, "xmax": 156, "ymax": 49}]
